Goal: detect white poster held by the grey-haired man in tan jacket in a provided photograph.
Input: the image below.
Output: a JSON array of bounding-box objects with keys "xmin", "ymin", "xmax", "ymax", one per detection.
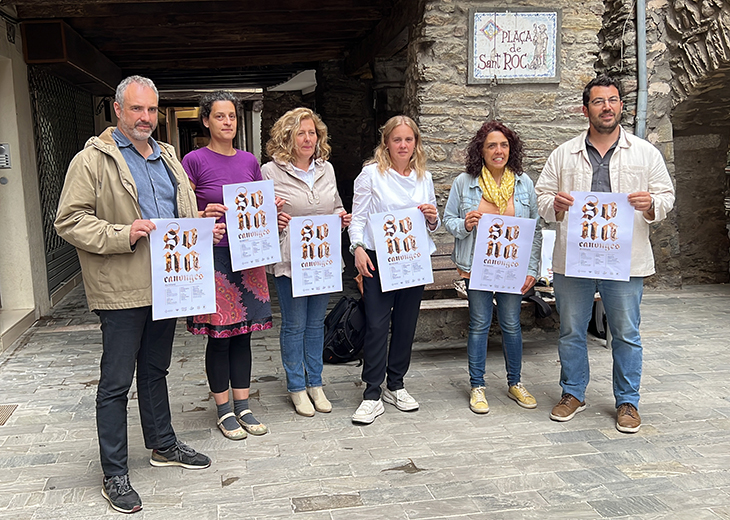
[{"xmin": 150, "ymin": 218, "xmax": 215, "ymax": 320}]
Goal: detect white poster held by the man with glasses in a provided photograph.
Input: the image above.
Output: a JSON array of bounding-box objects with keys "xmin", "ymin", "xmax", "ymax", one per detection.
[{"xmin": 565, "ymin": 191, "xmax": 635, "ymax": 281}]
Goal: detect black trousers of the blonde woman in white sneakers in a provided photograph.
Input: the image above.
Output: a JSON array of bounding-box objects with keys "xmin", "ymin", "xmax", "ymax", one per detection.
[{"xmin": 362, "ymin": 250, "xmax": 424, "ymax": 400}]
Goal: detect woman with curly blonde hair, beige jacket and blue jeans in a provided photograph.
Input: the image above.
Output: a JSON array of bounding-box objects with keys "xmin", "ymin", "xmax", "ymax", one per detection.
[{"xmin": 261, "ymin": 108, "xmax": 351, "ymax": 417}]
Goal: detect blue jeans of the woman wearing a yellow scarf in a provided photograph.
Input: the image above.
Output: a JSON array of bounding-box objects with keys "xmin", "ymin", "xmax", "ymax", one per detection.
[{"xmin": 466, "ymin": 279, "xmax": 522, "ymax": 388}]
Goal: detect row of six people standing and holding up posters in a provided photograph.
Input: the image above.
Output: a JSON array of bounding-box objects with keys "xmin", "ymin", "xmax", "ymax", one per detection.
[{"xmin": 56, "ymin": 76, "xmax": 674, "ymax": 513}]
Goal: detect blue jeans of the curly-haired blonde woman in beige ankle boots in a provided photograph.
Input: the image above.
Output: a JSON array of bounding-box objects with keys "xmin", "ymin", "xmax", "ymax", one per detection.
[{"xmin": 274, "ymin": 276, "xmax": 330, "ymax": 392}]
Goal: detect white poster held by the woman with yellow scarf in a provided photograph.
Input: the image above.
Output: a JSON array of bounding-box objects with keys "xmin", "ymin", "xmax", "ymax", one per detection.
[{"xmin": 469, "ymin": 213, "xmax": 537, "ymax": 294}]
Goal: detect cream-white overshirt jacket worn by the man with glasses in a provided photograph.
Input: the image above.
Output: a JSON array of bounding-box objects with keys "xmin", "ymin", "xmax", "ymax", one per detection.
[{"xmin": 535, "ymin": 127, "xmax": 674, "ymax": 276}]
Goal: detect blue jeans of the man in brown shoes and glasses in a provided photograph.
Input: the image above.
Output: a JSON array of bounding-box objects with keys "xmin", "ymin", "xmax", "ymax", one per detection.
[{"xmin": 553, "ymin": 273, "xmax": 644, "ymax": 409}]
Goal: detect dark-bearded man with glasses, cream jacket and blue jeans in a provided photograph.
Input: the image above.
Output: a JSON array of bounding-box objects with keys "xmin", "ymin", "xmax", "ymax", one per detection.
[{"xmin": 535, "ymin": 76, "xmax": 674, "ymax": 433}]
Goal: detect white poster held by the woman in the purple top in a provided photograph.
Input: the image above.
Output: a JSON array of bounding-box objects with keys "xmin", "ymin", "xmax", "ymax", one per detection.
[{"xmin": 223, "ymin": 181, "xmax": 281, "ymax": 271}]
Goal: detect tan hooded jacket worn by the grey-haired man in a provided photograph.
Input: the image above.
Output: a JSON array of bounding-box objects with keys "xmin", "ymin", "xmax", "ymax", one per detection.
[{"xmin": 55, "ymin": 127, "xmax": 198, "ymax": 310}]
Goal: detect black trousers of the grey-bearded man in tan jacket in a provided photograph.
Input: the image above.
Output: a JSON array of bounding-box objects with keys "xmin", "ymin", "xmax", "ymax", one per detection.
[{"xmin": 96, "ymin": 307, "xmax": 177, "ymax": 476}]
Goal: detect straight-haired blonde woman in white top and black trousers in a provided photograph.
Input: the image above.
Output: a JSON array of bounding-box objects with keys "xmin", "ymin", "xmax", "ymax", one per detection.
[{"xmin": 350, "ymin": 116, "xmax": 440, "ymax": 424}]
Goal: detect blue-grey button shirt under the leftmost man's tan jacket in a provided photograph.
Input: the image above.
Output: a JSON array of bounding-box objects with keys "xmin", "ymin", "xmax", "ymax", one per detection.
[{"xmin": 112, "ymin": 128, "xmax": 177, "ymax": 219}]
